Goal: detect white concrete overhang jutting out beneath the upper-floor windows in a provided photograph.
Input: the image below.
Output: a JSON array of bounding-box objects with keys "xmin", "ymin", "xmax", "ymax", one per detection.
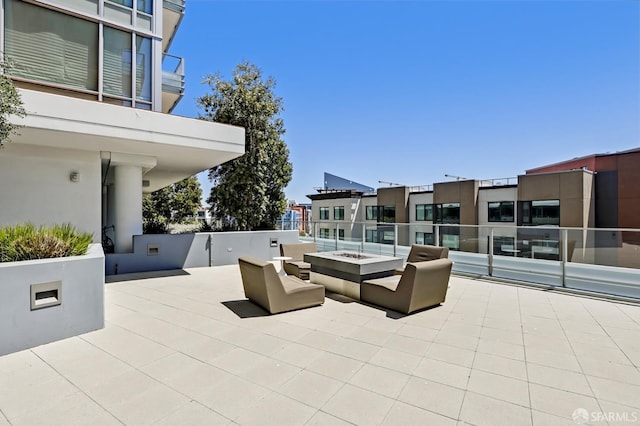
[{"xmin": 11, "ymin": 89, "xmax": 245, "ymax": 192}]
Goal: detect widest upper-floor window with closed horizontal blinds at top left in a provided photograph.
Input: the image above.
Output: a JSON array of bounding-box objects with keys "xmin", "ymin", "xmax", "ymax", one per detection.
[{"xmin": 4, "ymin": 0, "xmax": 99, "ymax": 92}]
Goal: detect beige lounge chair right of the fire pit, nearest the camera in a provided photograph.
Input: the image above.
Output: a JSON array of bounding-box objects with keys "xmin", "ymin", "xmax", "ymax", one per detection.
[{"xmin": 360, "ymin": 259, "xmax": 453, "ymax": 314}]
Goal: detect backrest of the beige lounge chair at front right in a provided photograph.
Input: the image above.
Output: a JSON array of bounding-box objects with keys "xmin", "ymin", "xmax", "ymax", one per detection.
[{"xmin": 396, "ymin": 259, "xmax": 453, "ymax": 311}]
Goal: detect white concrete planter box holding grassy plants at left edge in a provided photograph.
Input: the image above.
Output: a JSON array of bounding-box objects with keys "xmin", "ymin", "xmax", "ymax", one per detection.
[{"xmin": 0, "ymin": 244, "xmax": 104, "ymax": 356}]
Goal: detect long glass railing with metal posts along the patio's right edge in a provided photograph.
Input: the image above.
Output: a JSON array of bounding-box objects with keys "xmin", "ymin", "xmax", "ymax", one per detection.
[{"xmin": 279, "ymin": 221, "xmax": 640, "ymax": 299}]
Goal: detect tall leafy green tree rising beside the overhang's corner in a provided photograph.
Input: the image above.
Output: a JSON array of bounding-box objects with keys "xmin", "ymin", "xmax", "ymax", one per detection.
[{"xmin": 197, "ymin": 62, "xmax": 293, "ymax": 230}]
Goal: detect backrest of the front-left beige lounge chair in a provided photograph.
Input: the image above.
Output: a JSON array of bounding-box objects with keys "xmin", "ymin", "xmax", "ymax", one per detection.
[{"xmin": 238, "ymin": 256, "xmax": 284, "ymax": 310}]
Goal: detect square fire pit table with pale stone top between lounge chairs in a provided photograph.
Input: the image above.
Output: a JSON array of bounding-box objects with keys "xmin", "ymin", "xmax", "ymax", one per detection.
[{"xmin": 304, "ymin": 250, "xmax": 403, "ymax": 300}]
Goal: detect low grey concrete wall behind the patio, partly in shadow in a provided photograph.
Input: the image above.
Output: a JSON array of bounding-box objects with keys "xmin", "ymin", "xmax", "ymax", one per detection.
[{"xmin": 105, "ymin": 230, "xmax": 298, "ymax": 275}]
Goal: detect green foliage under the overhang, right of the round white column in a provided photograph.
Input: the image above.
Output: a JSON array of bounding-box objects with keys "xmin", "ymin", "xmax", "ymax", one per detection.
[{"xmin": 142, "ymin": 176, "xmax": 202, "ymax": 234}]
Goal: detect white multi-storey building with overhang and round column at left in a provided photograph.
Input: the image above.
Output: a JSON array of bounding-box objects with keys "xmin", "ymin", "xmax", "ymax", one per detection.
[{"xmin": 0, "ymin": 0, "xmax": 245, "ymax": 253}]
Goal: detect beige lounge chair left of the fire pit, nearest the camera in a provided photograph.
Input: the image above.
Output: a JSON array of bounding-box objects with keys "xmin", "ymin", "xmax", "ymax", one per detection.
[{"xmin": 238, "ymin": 256, "xmax": 324, "ymax": 314}]
